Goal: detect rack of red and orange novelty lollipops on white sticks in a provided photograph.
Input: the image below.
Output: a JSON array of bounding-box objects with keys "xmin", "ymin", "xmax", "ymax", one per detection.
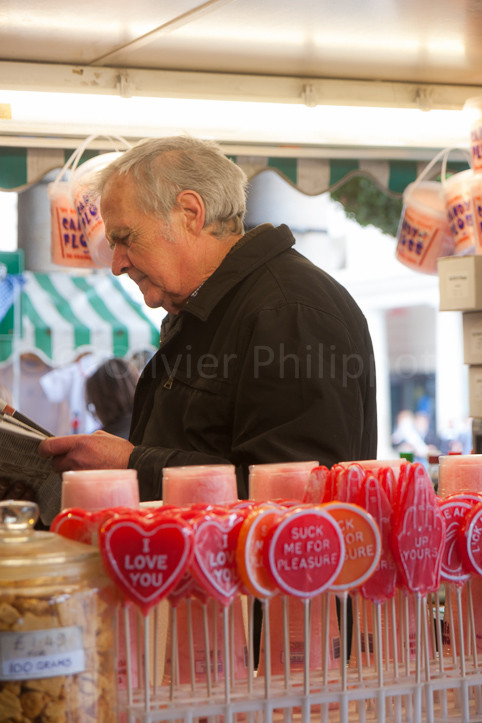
[{"xmin": 48, "ymin": 461, "xmax": 482, "ymax": 723}]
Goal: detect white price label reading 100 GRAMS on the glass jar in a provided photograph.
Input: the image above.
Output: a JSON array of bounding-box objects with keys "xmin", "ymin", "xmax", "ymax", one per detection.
[{"xmin": 0, "ymin": 625, "xmax": 85, "ymax": 680}]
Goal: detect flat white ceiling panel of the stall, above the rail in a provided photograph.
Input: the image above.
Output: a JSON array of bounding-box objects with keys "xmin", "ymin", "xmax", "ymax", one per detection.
[{"xmin": 0, "ymin": 0, "xmax": 482, "ymax": 85}]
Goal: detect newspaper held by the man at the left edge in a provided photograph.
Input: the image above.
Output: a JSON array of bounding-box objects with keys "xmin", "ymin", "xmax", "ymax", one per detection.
[{"xmin": 0, "ymin": 414, "xmax": 62, "ymax": 526}]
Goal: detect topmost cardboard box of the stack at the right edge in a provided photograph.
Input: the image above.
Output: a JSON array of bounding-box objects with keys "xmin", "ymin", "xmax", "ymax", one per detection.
[{"xmin": 437, "ymin": 255, "xmax": 482, "ymax": 311}]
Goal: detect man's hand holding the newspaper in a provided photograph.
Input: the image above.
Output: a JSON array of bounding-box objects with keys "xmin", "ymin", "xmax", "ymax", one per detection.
[{"xmin": 38, "ymin": 431, "xmax": 134, "ymax": 473}]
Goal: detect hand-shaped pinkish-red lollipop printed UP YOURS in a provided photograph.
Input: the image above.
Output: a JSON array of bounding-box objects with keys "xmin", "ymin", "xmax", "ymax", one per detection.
[{"xmin": 391, "ymin": 464, "xmax": 445, "ymax": 595}]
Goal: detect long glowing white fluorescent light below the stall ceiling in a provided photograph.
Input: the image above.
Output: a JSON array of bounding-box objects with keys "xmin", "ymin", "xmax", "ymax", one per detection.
[{"xmin": 0, "ymin": 90, "xmax": 470, "ymax": 148}]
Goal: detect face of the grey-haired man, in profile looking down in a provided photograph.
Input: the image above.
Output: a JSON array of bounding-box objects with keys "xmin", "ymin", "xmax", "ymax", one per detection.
[{"xmin": 101, "ymin": 174, "xmax": 202, "ymax": 313}]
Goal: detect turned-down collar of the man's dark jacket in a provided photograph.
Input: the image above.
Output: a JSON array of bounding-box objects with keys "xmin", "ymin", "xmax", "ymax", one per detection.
[{"xmin": 179, "ymin": 223, "xmax": 295, "ymax": 320}]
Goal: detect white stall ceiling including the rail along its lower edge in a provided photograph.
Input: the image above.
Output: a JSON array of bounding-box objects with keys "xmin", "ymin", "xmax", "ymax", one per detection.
[{"xmin": 0, "ymin": 0, "xmax": 482, "ymax": 153}]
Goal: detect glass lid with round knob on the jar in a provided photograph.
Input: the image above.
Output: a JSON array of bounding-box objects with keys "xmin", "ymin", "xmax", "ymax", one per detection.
[{"xmin": 0, "ymin": 500, "xmax": 99, "ymax": 579}]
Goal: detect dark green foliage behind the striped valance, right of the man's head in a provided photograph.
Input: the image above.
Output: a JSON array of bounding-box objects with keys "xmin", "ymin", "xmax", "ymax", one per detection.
[{"xmin": 330, "ymin": 176, "xmax": 402, "ymax": 236}]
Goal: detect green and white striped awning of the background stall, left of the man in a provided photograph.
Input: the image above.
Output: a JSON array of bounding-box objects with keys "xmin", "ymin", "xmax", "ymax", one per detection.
[{"xmin": 0, "ymin": 271, "xmax": 159, "ymax": 367}]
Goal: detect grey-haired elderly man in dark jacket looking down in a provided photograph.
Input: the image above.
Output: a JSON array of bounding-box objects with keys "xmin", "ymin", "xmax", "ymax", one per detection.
[{"xmin": 39, "ymin": 136, "xmax": 377, "ymax": 500}]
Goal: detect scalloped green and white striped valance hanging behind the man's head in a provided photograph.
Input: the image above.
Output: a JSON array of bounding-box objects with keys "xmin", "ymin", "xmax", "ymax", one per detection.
[{"xmin": 0, "ymin": 146, "xmax": 467, "ymax": 196}]
